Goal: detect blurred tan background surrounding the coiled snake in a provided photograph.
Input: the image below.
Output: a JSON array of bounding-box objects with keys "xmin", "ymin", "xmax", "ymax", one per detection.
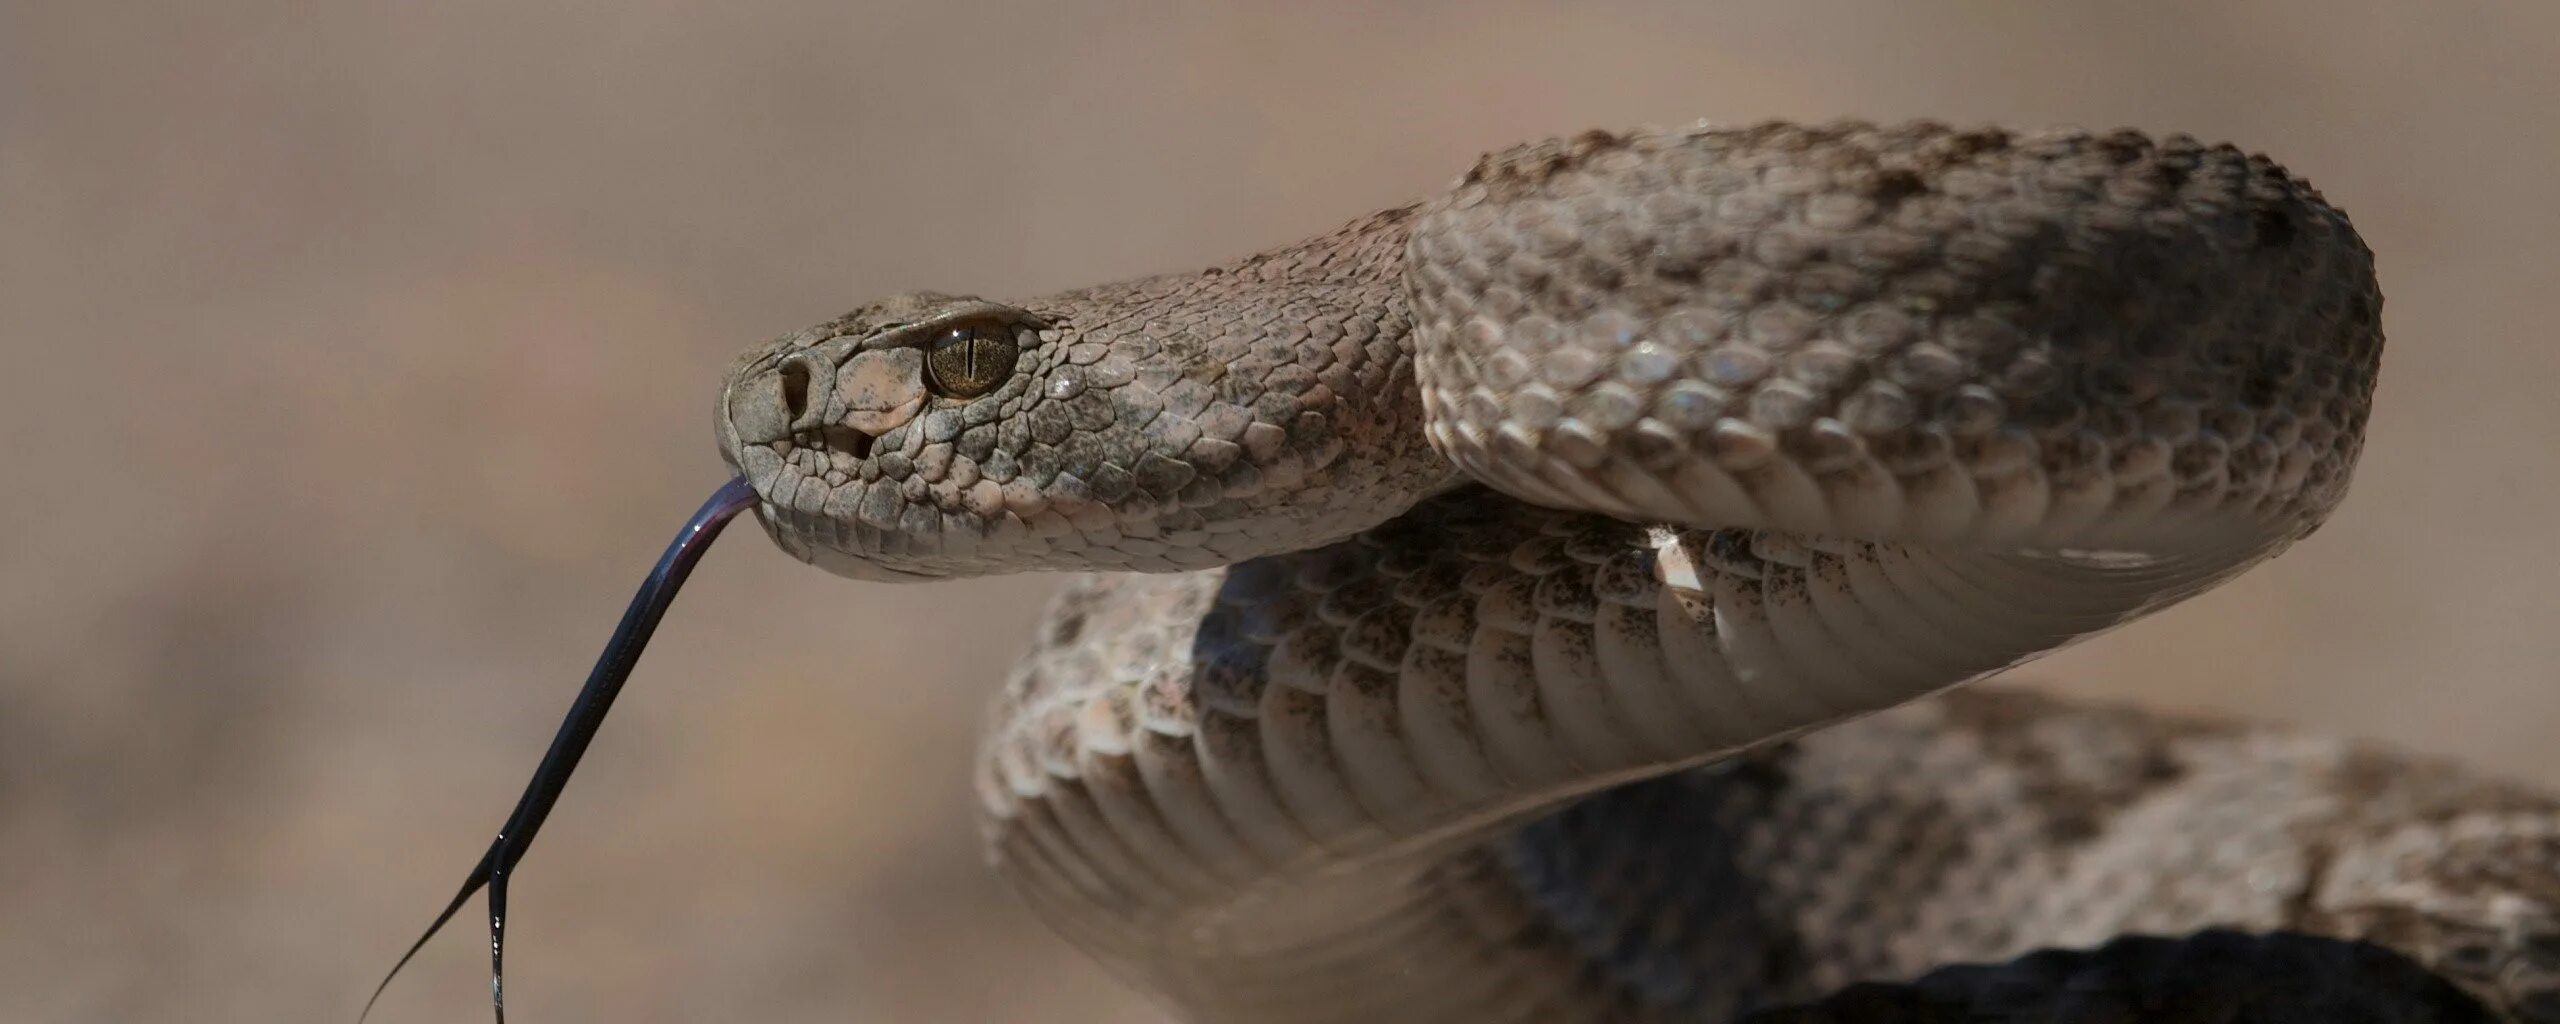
[{"xmin": 0, "ymin": 0, "xmax": 2560, "ymax": 1024}]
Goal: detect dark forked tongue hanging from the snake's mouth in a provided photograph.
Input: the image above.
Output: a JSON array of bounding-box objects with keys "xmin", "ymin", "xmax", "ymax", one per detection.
[{"xmin": 356, "ymin": 479, "xmax": 755, "ymax": 1024}]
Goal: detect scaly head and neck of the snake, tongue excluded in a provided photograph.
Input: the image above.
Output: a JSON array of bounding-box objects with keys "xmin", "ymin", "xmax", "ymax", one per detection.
[{"xmin": 719, "ymin": 264, "xmax": 1449, "ymax": 581}]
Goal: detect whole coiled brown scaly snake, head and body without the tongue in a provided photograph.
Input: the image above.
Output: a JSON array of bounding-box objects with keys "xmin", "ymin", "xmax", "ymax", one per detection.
[{"xmin": 717, "ymin": 123, "xmax": 2560, "ymax": 1024}]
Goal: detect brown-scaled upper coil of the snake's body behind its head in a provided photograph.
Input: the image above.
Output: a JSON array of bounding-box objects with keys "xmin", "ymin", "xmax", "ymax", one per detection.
[{"xmin": 1408, "ymin": 125, "xmax": 2381, "ymax": 545}]
